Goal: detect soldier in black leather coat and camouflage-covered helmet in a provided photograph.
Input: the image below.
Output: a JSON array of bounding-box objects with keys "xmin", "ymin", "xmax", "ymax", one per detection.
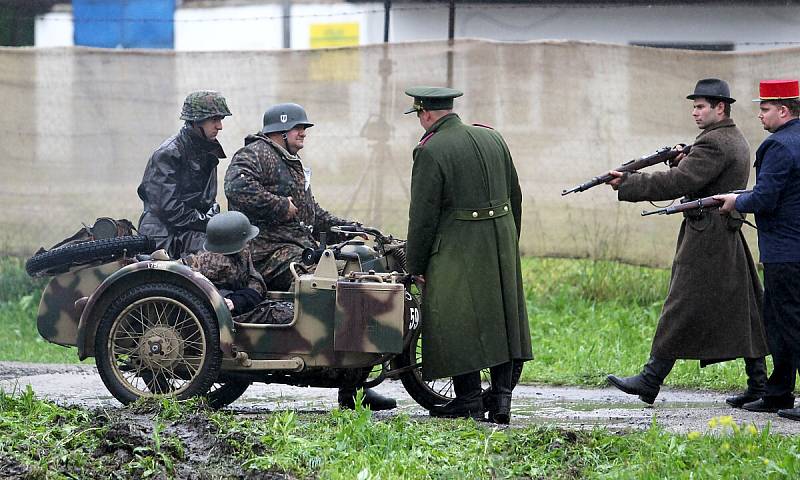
[{"xmin": 137, "ymin": 90, "xmax": 231, "ymax": 258}]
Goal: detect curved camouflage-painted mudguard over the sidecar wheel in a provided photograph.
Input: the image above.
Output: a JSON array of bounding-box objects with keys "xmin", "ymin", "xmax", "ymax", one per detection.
[{"xmin": 77, "ymin": 260, "xmax": 236, "ymax": 360}]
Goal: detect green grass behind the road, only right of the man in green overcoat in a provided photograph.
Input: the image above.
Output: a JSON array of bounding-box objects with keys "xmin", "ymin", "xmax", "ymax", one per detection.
[{"xmin": 522, "ymin": 258, "xmax": 746, "ymax": 391}]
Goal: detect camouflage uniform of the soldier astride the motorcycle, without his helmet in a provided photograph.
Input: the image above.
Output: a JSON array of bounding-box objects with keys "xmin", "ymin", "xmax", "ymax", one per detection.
[{"xmin": 225, "ymin": 133, "xmax": 351, "ymax": 284}]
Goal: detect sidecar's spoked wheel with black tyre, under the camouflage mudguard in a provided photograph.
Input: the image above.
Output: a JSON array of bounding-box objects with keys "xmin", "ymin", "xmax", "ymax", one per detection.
[{"xmin": 95, "ymin": 283, "xmax": 222, "ymax": 404}]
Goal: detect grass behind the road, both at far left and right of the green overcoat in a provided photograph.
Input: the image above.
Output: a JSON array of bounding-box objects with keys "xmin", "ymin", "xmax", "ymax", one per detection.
[{"xmin": 0, "ymin": 257, "xmax": 764, "ymax": 391}]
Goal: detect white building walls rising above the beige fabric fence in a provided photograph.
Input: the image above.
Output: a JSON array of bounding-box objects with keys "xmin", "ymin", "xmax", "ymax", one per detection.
[{"xmin": 36, "ymin": 2, "xmax": 800, "ymax": 51}]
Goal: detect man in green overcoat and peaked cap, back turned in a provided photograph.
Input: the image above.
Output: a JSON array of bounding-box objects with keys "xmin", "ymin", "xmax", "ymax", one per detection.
[{"xmin": 406, "ymin": 87, "xmax": 533, "ymax": 423}]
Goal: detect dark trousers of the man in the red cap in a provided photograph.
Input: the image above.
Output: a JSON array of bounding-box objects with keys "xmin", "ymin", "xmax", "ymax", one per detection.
[{"xmin": 764, "ymin": 263, "xmax": 800, "ymax": 399}]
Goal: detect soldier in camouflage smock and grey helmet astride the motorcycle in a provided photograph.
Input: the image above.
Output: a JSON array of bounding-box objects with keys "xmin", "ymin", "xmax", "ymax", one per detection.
[{"xmin": 225, "ymin": 103, "xmax": 397, "ymax": 410}]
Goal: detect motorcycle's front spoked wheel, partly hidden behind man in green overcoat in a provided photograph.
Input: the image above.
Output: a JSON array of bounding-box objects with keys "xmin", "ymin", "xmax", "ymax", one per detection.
[{"xmin": 393, "ymin": 330, "xmax": 523, "ymax": 410}]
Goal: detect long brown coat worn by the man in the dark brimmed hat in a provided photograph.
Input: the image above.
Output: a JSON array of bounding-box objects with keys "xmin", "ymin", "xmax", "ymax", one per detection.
[{"xmin": 618, "ymin": 119, "xmax": 768, "ymax": 363}]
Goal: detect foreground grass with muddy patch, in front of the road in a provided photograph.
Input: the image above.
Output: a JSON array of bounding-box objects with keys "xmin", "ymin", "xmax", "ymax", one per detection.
[{"xmin": 0, "ymin": 390, "xmax": 800, "ymax": 480}]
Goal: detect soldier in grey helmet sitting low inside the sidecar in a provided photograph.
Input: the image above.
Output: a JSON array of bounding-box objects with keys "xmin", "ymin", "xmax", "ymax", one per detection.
[{"xmin": 182, "ymin": 212, "xmax": 267, "ymax": 316}]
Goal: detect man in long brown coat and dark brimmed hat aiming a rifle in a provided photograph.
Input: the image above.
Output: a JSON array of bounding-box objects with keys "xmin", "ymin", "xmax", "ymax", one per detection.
[{"xmin": 608, "ymin": 78, "xmax": 768, "ymax": 407}]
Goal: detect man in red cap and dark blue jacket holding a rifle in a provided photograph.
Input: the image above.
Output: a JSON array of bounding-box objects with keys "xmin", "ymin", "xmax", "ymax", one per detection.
[{"xmin": 715, "ymin": 80, "xmax": 800, "ymax": 420}]
